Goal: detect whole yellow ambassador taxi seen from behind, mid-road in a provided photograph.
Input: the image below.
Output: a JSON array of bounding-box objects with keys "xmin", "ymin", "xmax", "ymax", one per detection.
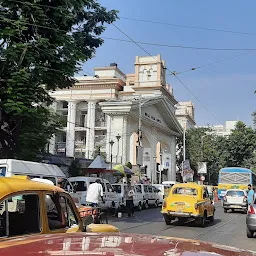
[{"xmin": 161, "ymin": 183, "xmax": 215, "ymax": 227}]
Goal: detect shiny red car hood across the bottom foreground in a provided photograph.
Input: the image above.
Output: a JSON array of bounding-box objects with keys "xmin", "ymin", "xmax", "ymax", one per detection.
[{"xmin": 0, "ymin": 233, "xmax": 256, "ymax": 256}]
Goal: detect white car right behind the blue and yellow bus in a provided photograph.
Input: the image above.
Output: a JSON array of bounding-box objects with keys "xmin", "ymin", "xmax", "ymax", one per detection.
[{"xmin": 223, "ymin": 189, "xmax": 248, "ymax": 213}]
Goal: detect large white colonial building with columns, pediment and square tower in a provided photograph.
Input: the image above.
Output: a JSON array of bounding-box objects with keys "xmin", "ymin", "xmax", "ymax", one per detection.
[{"xmin": 50, "ymin": 55, "xmax": 193, "ymax": 182}]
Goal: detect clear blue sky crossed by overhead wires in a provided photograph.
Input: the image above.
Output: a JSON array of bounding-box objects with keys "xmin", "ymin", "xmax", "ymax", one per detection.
[{"xmin": 80, "ymin": 0, "xmax": 256, "ymax": 125}]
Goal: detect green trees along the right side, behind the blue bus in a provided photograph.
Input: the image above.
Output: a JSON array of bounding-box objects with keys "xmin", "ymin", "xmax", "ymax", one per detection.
[{"xmin": 178, "ymin": 121, "xmax": 256, "ymax": 183}]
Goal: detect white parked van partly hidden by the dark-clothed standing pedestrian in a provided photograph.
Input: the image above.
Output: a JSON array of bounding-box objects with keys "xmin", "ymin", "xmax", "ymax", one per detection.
[{"xmin": 112, "ymin": 183, "xmax": 144, "ymax": 211}]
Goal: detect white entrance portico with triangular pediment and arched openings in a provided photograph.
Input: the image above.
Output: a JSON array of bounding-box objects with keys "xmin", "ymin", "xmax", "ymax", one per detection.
[{"xmin": 100, "ymin": 97, "xmax": 182, "ymax": 182}]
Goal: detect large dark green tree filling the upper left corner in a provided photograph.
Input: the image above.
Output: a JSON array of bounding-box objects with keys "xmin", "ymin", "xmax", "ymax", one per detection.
[{"xmin": 0, "ymin": 0, "xmax": 117, "ymax": 158}]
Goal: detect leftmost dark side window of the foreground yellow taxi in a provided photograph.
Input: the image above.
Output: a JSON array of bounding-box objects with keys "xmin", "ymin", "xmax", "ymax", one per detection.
[{"xmin": 0, "ymin": 194, "xmax": 41, "ymax": 237}]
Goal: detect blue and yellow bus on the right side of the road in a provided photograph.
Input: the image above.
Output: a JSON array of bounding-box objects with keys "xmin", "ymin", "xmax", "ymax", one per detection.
[{"xmin": 218, "ymin": 167, "xmax": 256, "ymax": 200}]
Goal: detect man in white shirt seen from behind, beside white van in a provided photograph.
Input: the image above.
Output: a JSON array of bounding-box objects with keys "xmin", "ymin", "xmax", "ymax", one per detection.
[{"xmin": 86, "ymin": 179, "xmax": 105, "ymax": 207}]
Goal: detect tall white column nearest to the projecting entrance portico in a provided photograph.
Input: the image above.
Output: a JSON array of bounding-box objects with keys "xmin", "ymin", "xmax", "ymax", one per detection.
[{"xmin": 85, "ymin": 101, "xmax": 96, "ymax": 159}]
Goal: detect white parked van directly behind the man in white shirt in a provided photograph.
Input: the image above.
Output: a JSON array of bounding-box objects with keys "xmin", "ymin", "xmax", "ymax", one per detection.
[{"xmin": 69, "ymin": 176, "xmax": 120, "ymax": 210}]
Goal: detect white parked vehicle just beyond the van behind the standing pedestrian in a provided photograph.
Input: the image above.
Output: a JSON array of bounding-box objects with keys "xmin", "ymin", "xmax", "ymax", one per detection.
[{"xmin": 135, "ymin": 184, "xmax": 158, "ymax": 209}]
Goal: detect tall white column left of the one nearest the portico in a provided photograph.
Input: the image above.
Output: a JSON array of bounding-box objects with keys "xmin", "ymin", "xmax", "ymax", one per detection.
[{"xmin": 66, "ymin": 100, "xmax": 77, "ymax": 157}]
